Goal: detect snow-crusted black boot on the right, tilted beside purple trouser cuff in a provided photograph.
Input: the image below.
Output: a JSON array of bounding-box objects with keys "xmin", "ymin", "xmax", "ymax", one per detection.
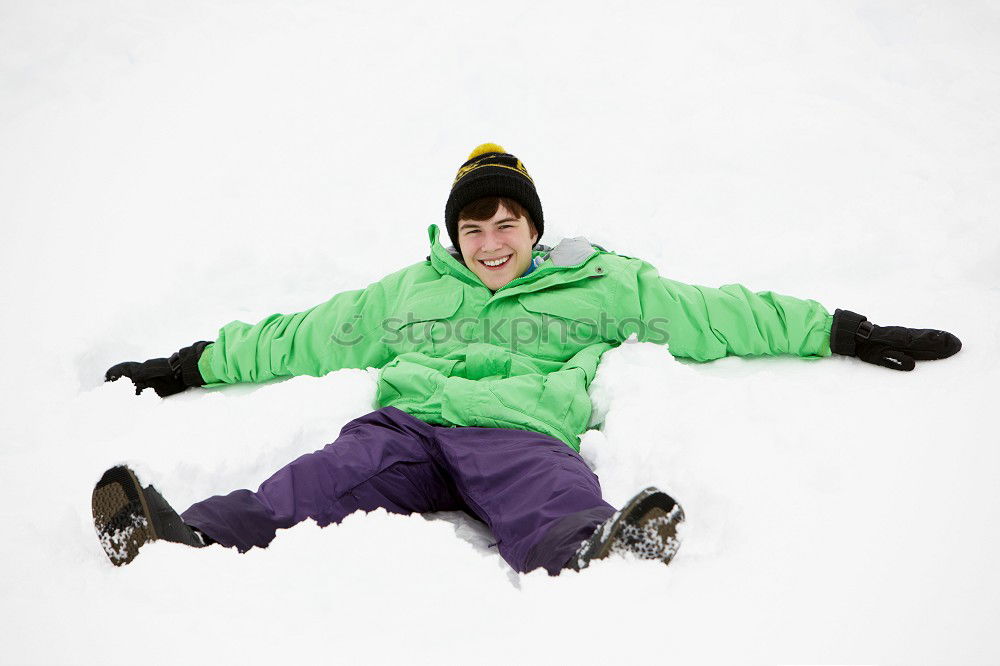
[{"xmin": 566, "ymin": 487, "xmax": 684, "ymax": 571}]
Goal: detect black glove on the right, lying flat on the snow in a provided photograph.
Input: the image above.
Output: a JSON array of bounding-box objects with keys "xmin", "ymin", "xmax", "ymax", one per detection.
[{"xmin": 830, "ymin": 308, "xmax": 962, "ymax": 370}]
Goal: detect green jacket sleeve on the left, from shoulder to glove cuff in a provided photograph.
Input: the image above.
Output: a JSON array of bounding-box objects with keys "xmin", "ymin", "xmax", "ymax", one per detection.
[{"xmin": 198, "ymin": 282, "xmax": 392, "ymax": 385}]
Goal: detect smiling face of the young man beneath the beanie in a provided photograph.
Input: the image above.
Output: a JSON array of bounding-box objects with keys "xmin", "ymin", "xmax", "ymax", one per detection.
[{"xmin": 458, "ymin": 204, "xmax": 538, "ymax": 291}]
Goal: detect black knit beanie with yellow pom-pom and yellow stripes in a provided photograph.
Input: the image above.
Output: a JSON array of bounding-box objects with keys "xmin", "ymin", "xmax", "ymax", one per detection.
[{"xmin": 444, "ymin": 143, "xmax": 545, "ymax": 249}]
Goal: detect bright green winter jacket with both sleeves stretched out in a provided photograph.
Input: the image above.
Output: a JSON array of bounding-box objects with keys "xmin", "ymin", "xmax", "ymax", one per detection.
[{"xmin": 198, "ymin": 225, "xmax": 832, "ymax": 449}]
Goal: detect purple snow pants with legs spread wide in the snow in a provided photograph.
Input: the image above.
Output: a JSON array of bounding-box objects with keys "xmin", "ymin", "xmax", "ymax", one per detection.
[{"xmin": 181, "ymin": 407, "xmax": 615, "ymax": 574}]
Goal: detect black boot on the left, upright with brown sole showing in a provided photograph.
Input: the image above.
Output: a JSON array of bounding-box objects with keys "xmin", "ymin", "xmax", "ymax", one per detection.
[{"xmin": 92, "ymin": 466, "xmax": 207, "ymax": 566}]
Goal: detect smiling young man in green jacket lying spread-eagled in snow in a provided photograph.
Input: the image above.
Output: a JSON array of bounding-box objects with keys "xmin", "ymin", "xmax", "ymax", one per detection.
[{"xmin": 93, "ymin": 144, "xmax": 961, "ymax": 574}]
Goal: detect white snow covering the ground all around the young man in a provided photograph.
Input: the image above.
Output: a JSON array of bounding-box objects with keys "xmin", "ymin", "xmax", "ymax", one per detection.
[{"xmin": 0, "ymin": 0, "xmax": 1000, "ymax": 665}]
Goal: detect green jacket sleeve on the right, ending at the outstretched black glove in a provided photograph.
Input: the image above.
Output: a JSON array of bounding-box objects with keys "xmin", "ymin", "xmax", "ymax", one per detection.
[{"xmin": 637, "ymin": 262, "xmax": 833, "ymax": 361}]
